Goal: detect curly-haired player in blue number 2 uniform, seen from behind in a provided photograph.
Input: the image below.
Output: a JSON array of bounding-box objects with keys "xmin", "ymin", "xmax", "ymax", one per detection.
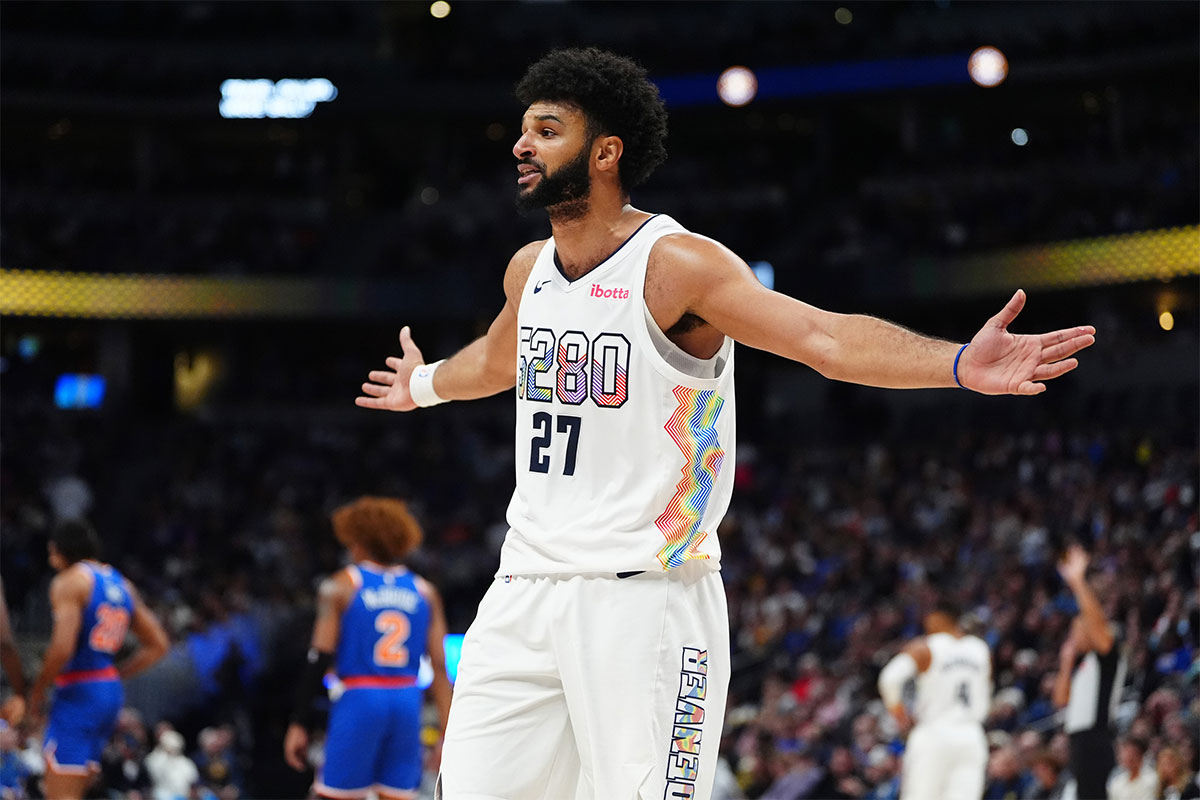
[{"xmin": 283, "ymin": 497, "xmax": 451, "ymax": 800}]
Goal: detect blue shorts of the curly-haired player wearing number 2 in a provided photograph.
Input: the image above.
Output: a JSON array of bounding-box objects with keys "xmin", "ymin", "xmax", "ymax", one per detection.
[{"xmin": 314, "ymin": 686, "xmax": 421, "ymax": 798}]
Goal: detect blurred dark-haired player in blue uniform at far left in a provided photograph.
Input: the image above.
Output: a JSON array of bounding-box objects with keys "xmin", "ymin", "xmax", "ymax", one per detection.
[{"xmin": 29, "ymin": 519, "xmax": 169, "ymax": 800}]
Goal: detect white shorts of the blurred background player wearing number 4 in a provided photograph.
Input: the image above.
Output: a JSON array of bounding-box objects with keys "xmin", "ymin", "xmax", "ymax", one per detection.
[{"xmin": 900, "ymin": 722, "xmax": 988, "ymax": 800}]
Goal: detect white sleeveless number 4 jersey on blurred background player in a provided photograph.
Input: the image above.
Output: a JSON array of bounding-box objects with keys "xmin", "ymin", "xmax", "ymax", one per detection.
[{"xmin": 914, "ymin": 633, "xmax": 991, "ymax": 724}]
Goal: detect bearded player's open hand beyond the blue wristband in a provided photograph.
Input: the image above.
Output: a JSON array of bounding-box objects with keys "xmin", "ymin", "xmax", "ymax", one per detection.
[{"xmin": 959, "ymin": 289, "xmax": 1096, "ymax": 395}]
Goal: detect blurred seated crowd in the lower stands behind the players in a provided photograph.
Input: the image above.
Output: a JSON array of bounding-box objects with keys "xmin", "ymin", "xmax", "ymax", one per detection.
[{"xmin": 0, "ymin": 367, "xmax": 1200, "ymax": 800}]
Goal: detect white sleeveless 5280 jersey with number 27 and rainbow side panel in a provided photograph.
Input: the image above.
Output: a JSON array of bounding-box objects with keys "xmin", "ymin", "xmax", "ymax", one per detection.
[{"xmin": 497, "ymin": 215, "xmax": 734, "ymax": 576}]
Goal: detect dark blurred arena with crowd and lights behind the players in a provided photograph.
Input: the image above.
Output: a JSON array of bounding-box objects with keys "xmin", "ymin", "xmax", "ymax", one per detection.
[{"xmin": 0, "ymin": 0, "xmax": 1200, "ymax": 800}]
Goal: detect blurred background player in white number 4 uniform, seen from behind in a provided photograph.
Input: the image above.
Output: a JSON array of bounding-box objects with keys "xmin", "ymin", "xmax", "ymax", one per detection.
[{"xmin": 878, "ymin": 601, "xmax": 991, "ymax": 800}]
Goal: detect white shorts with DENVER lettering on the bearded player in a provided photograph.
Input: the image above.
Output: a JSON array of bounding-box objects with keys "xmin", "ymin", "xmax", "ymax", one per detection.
[{"xmin": 439, "ymin": 564, "xmax": 730, "ymax": 800}]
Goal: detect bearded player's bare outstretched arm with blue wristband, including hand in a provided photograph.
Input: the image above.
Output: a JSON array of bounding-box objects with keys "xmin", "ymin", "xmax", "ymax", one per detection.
[{"xmin": 667, "ymin": 235, "xmax": 1096, "ymax": 395}]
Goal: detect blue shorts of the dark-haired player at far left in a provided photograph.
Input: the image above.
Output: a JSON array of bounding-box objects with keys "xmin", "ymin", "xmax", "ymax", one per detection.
[{"xmin": 43, "ymin": 680, "xmax": 125, "ymax": 775}]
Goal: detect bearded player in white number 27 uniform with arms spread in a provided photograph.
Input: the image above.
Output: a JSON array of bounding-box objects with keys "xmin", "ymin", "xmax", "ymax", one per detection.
[{"xmin": 356, "ymin": 48, "xmax": 1094, "ymax": 800}]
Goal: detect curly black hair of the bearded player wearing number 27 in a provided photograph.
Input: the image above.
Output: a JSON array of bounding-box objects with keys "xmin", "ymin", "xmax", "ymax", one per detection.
[{"xmin": 516, "ymin": 47, "xmax": 667, "ymax": 192}]
